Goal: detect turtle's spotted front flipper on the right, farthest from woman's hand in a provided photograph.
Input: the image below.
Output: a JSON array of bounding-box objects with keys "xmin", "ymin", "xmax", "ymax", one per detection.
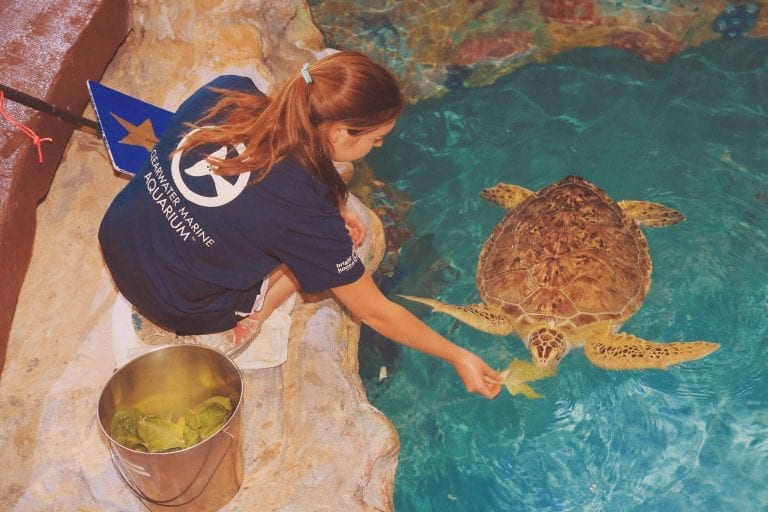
[{"xmin": 584, "ymin": 333, "xmax": 720, "ymax": 370}]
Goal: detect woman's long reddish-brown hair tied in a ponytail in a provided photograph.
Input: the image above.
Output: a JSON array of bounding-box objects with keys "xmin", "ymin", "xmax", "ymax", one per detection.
[{"xmin": 178, "ymin": 52, "xmax": 405, "ymax": 204}]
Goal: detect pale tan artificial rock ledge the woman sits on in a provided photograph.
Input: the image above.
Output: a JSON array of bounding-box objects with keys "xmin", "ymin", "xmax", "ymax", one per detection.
[{"xmin": 0, "ymin": 0, "xmax": 399, "ymax": 512}]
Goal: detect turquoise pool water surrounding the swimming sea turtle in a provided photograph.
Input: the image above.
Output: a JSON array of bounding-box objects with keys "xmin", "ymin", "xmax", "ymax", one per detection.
[{"xmin": 361, "ymin": 40, "xmax": 768, "ymax": 512}]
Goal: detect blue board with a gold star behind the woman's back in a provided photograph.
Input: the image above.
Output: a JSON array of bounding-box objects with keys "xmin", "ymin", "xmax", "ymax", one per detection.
[{"xmin": 87, "ymin": 80, "xmax": 173, "ymax": 175}]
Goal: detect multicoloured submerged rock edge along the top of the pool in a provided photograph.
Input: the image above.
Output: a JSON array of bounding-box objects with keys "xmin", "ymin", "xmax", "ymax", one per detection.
[{"xmin": 310, "ymin": 0, "xmax": 768, "ymax": 101}]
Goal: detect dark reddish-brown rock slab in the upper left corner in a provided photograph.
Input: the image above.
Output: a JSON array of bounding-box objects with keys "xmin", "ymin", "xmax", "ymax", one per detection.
[{"xmin": 0, "ymin": 0, "xmax": 128, "ymax": 372}]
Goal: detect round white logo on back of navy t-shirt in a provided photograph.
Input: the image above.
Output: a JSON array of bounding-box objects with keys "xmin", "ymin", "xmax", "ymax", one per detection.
[{"xmin": 171, "ymin": 130, "xmax": 250, "ymax": 208}]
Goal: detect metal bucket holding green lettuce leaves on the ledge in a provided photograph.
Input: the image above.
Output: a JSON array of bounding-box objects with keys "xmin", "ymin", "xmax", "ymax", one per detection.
[{"xmin": 98, "ymin": 345, "xmax": 244, "ymax": 511}]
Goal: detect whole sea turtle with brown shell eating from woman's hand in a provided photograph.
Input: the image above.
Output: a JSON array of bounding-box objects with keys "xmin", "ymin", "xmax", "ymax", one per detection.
[{"xmin": 404, "ymin": 176, "xmax": 719, "ymax": 384}]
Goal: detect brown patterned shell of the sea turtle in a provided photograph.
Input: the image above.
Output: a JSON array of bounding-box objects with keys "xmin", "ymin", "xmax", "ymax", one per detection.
[{"xmin": 477, "ymin": 176, "xmax": 651, "ymax": 328}]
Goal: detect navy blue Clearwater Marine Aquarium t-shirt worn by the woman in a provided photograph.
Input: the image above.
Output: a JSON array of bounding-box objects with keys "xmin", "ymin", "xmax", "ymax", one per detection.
[{"xmin": 99, "ymin": 76, "xmax": 365, "ymax": 334}]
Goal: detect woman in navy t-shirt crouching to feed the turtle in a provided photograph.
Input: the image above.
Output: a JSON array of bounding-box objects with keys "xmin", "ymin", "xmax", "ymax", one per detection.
[{"xmin": 99, "ymin": 52, "xmax": 500, "ymax": 398}]
